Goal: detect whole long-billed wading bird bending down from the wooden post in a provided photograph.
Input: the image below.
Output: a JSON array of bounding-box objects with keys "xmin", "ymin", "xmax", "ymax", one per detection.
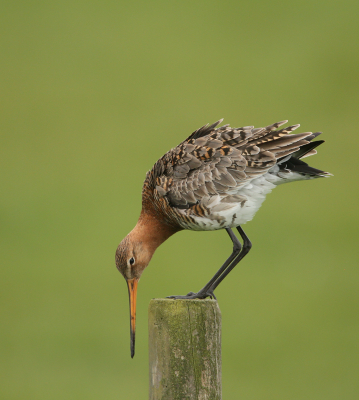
[{"xmin": 116, "ymin": 119, "xmax": 332, "ymax": 358}]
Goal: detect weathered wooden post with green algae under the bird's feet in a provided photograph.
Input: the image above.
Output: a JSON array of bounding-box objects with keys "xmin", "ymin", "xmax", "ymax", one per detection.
[{"xmin": 148, "ymin": 299, "xmax": 222, "ymax": 400}]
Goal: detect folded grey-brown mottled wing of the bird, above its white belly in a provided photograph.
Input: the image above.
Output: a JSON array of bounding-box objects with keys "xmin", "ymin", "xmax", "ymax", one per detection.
[{"xmin": 148, "ymin": 120, "xmax": 313, "ymax": 208}]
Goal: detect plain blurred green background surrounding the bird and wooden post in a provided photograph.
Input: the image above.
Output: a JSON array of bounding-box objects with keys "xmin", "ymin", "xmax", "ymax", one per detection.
[{"xmin": 0, "ymin": 0, "xmax": 359, "ymax": 400}]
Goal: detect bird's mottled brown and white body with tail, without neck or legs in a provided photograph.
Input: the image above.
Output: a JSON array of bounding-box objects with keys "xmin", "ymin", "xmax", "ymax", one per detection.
[{"xmin": 143, "ymin": 120, "xmax": 330, "ymax": 230}]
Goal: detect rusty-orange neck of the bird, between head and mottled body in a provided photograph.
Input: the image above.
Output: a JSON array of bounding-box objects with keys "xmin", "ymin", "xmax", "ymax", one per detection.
[{"xmin": 130, "ymin": 210, "xmax": 179, "ymax": 255}]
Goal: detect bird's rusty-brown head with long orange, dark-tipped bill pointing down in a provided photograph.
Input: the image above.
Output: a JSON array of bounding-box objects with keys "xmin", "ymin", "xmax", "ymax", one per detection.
[{"xmin": 116, "ymin": 233, "xmax": 154, "ymax": 358}]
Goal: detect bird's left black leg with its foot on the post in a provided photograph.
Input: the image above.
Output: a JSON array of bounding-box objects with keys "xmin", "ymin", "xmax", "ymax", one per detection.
[{"xmin": 167, "ymin": 228, "xmax": 244, "ymax": 299}]
